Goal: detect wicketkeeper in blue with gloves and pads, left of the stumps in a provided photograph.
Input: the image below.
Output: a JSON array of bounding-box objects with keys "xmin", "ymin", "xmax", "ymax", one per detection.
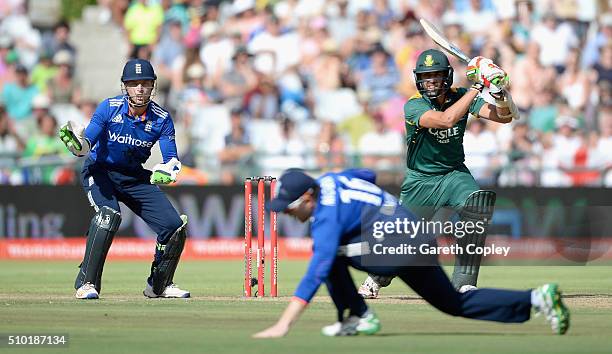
[{"xmin": 59, "ymin": 59, "xmax": 190, "ymax": 299}]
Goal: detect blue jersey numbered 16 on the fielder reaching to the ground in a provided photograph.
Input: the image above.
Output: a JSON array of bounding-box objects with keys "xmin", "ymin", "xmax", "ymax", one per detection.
[{"xmin": 294, "ymin": 169, "xmax": 398, "ymax": 302}]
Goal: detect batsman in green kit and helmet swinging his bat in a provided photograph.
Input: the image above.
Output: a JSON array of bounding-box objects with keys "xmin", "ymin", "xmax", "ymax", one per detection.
[{"xmin": 359, "ymin": 49, "xmax": 519, "ymax": 298}]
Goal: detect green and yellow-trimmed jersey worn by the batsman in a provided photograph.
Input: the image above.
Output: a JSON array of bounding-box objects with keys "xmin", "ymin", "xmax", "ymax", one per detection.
[{"xmin": 404, "ymin": 88, "xmax": 485, "ymax": 174}]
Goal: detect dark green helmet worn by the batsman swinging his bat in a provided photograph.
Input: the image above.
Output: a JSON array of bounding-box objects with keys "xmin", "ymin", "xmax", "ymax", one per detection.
[{"xmin": 412, "ymin": 49, "xmax": 453, "ymax": 99}]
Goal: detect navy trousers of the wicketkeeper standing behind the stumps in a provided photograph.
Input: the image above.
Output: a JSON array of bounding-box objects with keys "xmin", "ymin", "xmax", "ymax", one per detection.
[{"xmin": 81, "ymin": 160, "xmax": 183, "ymax": 276}]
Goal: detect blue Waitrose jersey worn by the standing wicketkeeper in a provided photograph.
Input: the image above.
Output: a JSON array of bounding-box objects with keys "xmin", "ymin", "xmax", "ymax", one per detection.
[{"xmin": 85, "ymin": 96, "xmax": 178, "ymax": 174}]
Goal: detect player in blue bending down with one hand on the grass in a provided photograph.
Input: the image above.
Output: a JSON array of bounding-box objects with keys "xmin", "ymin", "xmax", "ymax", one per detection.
[{"xmin": 253, "ymin": 169, "xmax": 569, "ymax": 338}]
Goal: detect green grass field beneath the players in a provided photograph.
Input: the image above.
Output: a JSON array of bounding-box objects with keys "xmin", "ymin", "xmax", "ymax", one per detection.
[{"xmin": 0, "ymin": 261, "xmax": 612, "ymax": 354}]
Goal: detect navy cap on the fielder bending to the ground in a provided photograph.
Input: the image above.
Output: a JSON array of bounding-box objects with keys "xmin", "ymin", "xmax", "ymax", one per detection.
[{"xmin": 266, "ymin": 168, "xmax": 317, "ymax": 212}]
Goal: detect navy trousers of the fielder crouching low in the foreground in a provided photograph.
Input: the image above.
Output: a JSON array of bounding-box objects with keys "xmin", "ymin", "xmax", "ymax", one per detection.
[{"xmin": 326, "ymin": 257, "xmax": 531, "ymax": 323}]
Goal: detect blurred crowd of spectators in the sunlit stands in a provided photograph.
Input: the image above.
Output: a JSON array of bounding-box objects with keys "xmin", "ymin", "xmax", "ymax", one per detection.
[{"xmin": 0, "ymin": 0, "xmax": 612, "ymax": 187}]
